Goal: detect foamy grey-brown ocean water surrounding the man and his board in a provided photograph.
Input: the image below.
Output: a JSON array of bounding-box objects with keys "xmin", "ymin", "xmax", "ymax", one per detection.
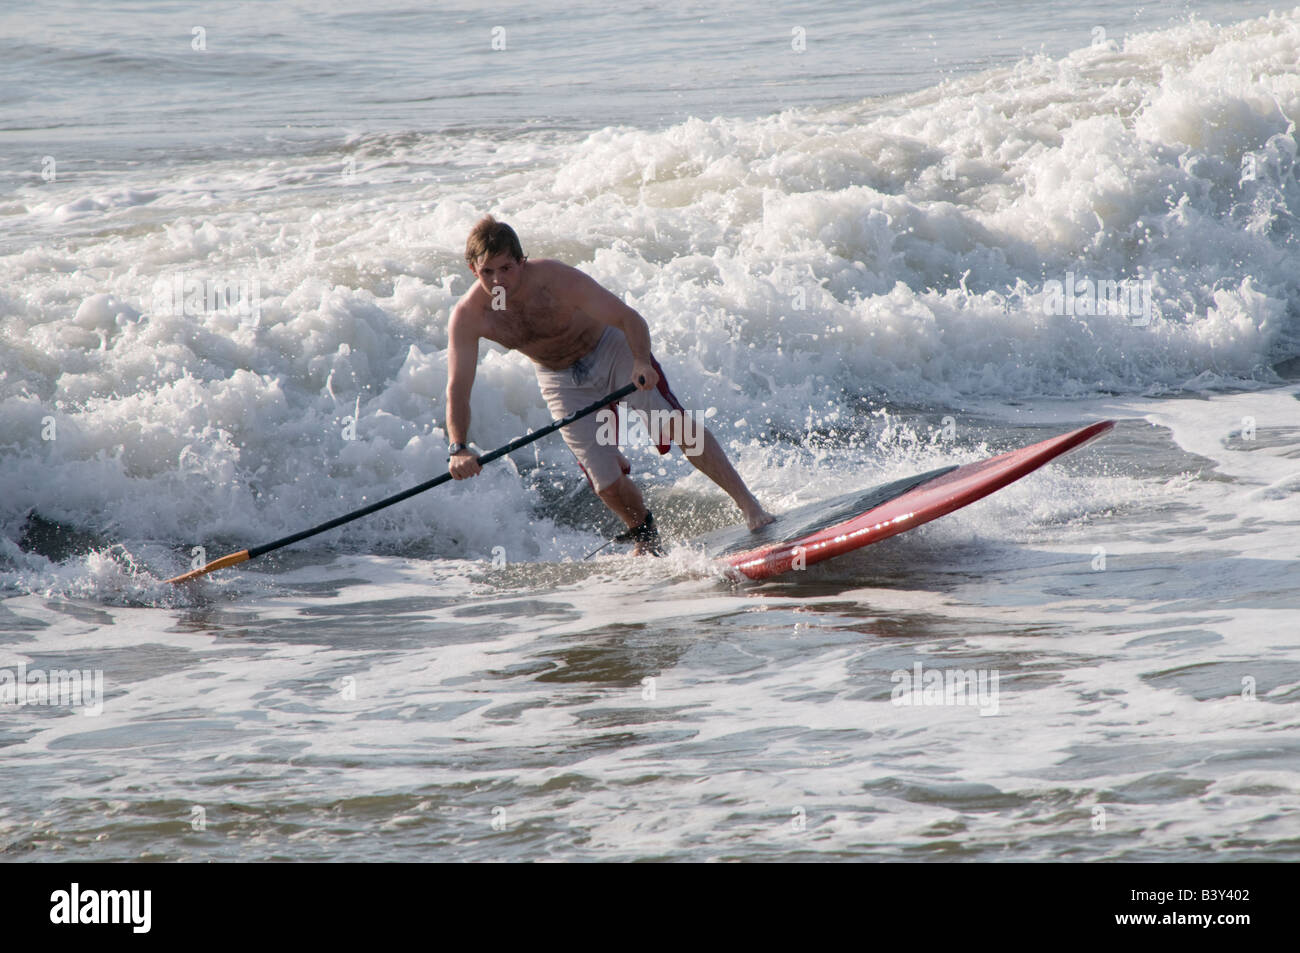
[{"xmin": 0, "ymin": 1, "xmax": 1300, "ymax": 861}]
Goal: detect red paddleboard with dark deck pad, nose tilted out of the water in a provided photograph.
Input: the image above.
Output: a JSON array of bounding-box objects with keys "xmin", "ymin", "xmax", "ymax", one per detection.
[{"xmin": 697, "ymin": 420, "xmax": 1115, "ymax": 579}]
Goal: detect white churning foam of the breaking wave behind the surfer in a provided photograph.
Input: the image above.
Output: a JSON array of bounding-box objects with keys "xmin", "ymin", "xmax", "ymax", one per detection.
[{"xmin": 0, "ymin": 12, "xmax": 1300, "ymax": 595}]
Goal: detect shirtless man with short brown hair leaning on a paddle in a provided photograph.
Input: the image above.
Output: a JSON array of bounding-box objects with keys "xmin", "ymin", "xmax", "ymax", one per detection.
[{"xmin": 447, "ymin": 216, "xmax": 775, "ymax": 554}]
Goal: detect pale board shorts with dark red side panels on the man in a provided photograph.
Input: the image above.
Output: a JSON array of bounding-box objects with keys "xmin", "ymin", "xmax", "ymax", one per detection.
[{"xmin": 537, "ymin": 328, "xmax": 683, "ymax": 493}]
